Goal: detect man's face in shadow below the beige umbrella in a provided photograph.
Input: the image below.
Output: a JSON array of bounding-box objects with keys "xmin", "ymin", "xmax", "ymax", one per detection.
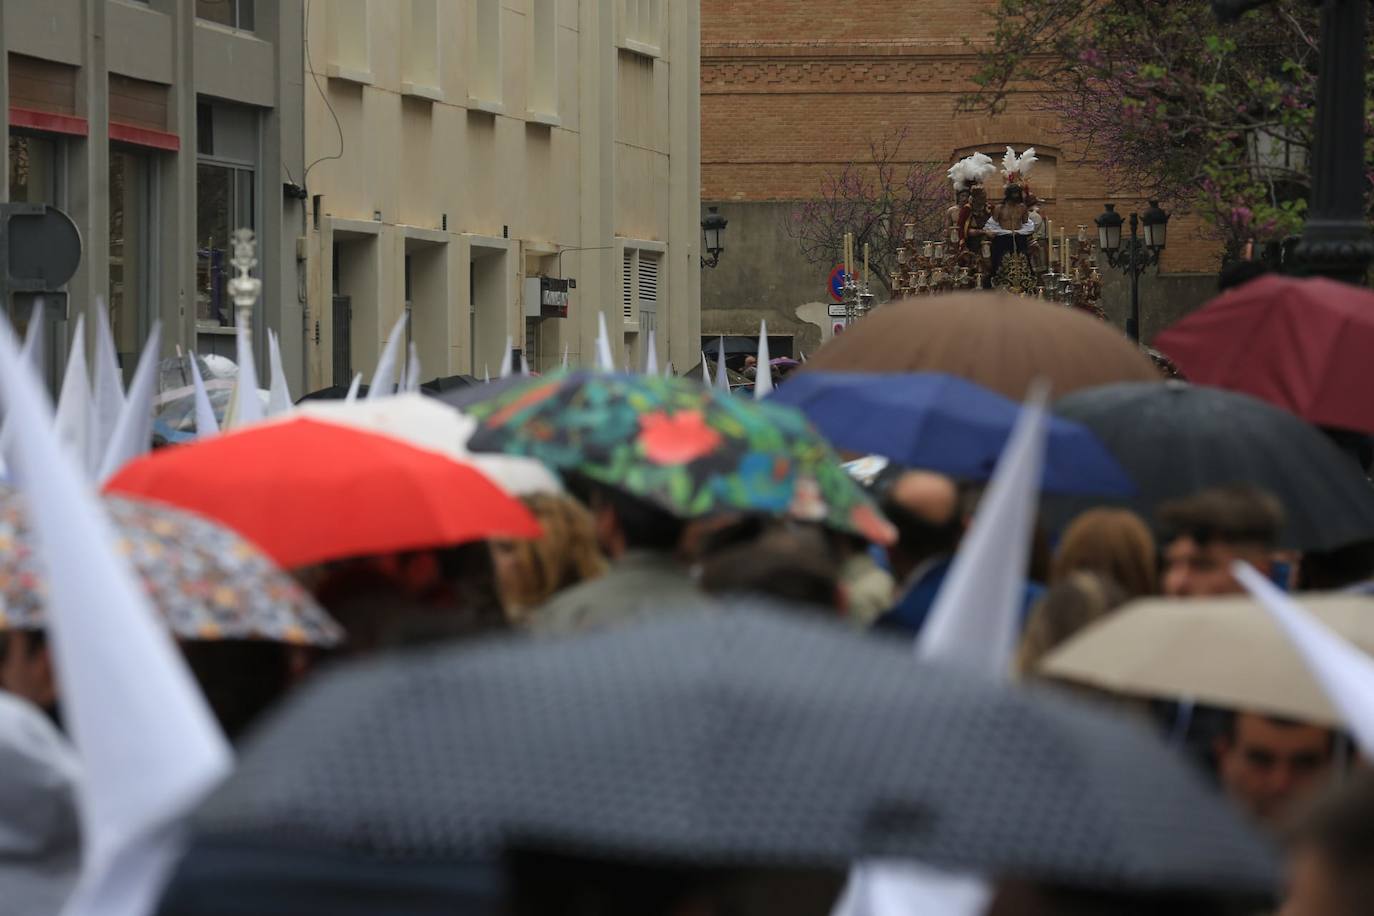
[{"xmin": 1216, "ymin": 713, "xmax": 1331, "ymax": 825}]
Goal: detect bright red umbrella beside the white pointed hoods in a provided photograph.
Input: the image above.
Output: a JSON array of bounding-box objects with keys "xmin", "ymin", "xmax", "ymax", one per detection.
[{"xmin": 106, "ymin": 419, "xmax": 540, "ymax": 567}]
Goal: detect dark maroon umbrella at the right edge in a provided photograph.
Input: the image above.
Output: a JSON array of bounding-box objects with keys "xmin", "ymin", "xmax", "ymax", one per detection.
[{"xmin": 1154, "ymin": 276, "xmax": 1374, "ymax": 433}]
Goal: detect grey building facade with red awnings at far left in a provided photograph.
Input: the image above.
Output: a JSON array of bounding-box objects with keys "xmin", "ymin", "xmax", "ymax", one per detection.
[{"xmin": 0, "ymin": 0, "xmax": 305, "ymax": 390}]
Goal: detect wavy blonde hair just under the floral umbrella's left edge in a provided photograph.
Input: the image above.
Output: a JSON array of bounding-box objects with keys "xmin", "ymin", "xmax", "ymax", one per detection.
[{"xmin": 497, "ymin": 493, "xmax": 606, "ymax": 621}]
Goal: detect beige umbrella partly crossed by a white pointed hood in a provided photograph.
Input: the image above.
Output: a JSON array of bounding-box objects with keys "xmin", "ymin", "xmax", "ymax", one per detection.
[{"xmin": 1039, "ymin": 595, "xmax": 1374, "ymax": 726}]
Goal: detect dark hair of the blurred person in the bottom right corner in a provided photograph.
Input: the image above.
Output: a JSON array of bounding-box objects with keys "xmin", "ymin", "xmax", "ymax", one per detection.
[{"xmin": 1290, "ymin": 770, "xmax": 1374, "ymax": 916}]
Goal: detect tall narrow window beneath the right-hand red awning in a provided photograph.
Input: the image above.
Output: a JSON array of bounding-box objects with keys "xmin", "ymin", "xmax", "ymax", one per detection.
[{"xmin": 109, "ymin": 147, "xmax": 157, "ymax": 380}]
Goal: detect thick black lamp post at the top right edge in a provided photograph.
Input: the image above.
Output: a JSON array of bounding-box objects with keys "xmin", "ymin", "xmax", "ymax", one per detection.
[{"xmin": 1212, "ymin": 0, "xmax": 1374, "ymax": 283}]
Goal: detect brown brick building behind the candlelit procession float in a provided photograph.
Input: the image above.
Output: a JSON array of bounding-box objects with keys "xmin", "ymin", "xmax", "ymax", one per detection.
[{"xmin": 702, "ymin": 0, "xmax": 1219, "ymax": 352}]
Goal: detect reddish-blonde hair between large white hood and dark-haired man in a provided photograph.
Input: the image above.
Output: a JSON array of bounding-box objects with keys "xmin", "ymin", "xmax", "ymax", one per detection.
[{"xmin": 1050, "ymin": 508, "xmax": 1160, "ymax": 597}]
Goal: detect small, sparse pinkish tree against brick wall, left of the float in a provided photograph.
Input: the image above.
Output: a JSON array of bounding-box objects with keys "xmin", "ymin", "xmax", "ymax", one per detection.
[{"xmin": 787, "ymin": 130, "xmax": 954, "ymax": 297}]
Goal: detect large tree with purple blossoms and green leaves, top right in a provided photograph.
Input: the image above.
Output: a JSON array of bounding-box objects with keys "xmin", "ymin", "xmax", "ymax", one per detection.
[{"xmin": 965, "ymin": 0, "xmax": 1374, "ymax": 258}]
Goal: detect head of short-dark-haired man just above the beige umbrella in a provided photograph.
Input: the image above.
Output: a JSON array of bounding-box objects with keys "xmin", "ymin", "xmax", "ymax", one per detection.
[{"xmin": 1160, "ymin": 486, "xmax": 1283, "ymax": 597}]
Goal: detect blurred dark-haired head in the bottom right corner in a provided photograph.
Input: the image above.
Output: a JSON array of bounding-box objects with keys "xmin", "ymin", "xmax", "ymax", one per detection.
[{"xmin": 1279, "ymin": 772, "xmax": 1374, "ymax": 916}]
